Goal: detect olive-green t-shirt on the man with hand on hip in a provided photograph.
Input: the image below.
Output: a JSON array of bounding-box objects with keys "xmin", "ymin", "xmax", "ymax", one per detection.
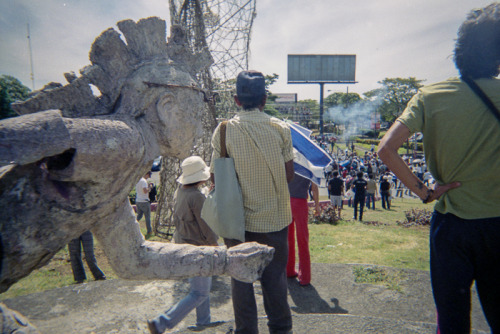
[{"xmin": 398, "ymin": 78, "xmax": 500, "ymax": 219}]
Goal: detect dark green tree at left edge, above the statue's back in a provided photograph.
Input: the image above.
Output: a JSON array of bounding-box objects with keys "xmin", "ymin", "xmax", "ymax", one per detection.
[{"xmin": 0, "ymin": 75, "xmax": 31, "ymax": 119}]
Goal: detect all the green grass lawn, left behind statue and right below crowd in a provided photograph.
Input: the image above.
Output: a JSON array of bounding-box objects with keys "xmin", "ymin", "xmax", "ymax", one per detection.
[{"xmin": 0, "ymin": 198, "xmax": 432, "ymax": 300}]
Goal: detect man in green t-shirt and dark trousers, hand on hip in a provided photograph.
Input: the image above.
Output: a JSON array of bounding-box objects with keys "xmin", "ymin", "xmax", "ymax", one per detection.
[{"xmin": 379, "ymin": 2, "xmax": 500, "ymax": 334}]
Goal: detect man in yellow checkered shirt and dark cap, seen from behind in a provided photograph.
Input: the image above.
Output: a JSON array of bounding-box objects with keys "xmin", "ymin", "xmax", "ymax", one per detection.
[{"xmin": 210, "ymin": 71, "xmax": 294, "ymax": 334}]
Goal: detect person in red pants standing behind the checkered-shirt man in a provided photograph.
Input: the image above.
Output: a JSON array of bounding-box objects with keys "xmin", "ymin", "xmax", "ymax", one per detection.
[{"xmin": 286, "ymin": 174, "xmax": 320, "ymax": 286}]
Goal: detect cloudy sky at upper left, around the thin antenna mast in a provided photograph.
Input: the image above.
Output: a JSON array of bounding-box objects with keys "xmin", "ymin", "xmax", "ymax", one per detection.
[{"xmin": 0, "ymin": 0, "xmax": 169, "ymax": 89}]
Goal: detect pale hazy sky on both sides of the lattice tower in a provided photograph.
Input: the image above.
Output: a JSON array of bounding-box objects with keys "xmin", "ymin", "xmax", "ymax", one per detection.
[{"xmin": 0, "ymin": 0, "xmax": 492, "ymax": 100}]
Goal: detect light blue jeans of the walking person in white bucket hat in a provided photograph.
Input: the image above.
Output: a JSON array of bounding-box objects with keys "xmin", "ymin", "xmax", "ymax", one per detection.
[{"xmin": 153, "ymin": 277, "xmax": 212, "ymax": 333}]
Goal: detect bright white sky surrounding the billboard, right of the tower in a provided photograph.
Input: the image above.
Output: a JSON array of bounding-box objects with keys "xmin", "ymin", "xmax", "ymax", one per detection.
[{"xmin": 251, "ymin": 0, "xmax": 490, "ymax": 99}]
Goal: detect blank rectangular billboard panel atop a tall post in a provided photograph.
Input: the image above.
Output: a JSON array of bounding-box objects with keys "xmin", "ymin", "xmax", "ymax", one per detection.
[{"xmin": 288, "ymin": 55, "xmax": 356, "ymax": 83}]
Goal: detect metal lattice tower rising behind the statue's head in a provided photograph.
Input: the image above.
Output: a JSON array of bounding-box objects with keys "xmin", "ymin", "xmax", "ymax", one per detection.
[{"xmin": 153, "ymin": 0, "xmax": 256, "ymax": 238}]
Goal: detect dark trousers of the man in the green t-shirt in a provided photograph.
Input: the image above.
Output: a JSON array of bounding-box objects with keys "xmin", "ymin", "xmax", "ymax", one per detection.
[{"xmin": 430, "ymin": 212, "xmax": 500, "ymax": 334}]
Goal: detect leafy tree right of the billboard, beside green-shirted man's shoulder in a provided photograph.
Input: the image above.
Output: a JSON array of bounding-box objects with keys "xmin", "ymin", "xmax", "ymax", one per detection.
[{"xmin": 364, "ymin": 77, "xmax": 424, "ymax": 124}]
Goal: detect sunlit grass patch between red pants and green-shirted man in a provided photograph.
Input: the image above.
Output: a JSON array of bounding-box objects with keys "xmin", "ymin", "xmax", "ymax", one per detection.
[{"xmin": 309, "ymin": 198, "xmax": 432, "ymax": 270}]
